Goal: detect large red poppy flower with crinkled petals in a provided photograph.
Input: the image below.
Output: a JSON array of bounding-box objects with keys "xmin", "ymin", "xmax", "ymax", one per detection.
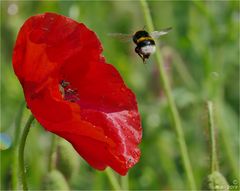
[{"xmin": 13, "ymin": 13, "xmax": 142, "ymax": 175}]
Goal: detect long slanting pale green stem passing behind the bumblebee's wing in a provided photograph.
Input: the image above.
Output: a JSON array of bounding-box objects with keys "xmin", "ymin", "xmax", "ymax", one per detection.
[{"xmin": 140, "ymin": 0, "xmax": 196, "ymax": 190}]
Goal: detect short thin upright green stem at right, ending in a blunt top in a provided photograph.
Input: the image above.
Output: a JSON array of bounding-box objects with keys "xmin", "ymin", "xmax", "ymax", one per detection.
[{"xmin": 207, "ymin": 101, "xmax": 219, "ymax": 173}]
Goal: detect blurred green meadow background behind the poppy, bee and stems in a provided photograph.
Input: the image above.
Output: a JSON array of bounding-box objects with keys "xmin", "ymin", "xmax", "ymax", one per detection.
[{"xmin": 0, "ymin": 0, "xmax": 240, "ymax": 190}]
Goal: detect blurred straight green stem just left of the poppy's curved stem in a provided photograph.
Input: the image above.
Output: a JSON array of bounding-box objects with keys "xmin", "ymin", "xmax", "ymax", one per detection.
[{"xmin": 12, "ymin": 102, "xmax": 25, "ymax": 190}]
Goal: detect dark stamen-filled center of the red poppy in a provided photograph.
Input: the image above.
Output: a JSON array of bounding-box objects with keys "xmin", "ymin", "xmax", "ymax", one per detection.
[{"xmin": 59, "ymin": 80, "xmax": 80, "ymax": 102}]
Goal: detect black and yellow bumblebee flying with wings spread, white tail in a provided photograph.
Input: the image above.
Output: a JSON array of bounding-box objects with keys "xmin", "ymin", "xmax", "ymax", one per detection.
[{"xmin": 110, "ymin": 27, "xmax": 172, "ymax": 64}]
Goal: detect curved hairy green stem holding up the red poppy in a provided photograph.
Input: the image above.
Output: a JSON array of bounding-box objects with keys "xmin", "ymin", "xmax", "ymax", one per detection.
[{"xmin": 18, "ymin": 114, "xmax": 34, "ymax": 190}]
